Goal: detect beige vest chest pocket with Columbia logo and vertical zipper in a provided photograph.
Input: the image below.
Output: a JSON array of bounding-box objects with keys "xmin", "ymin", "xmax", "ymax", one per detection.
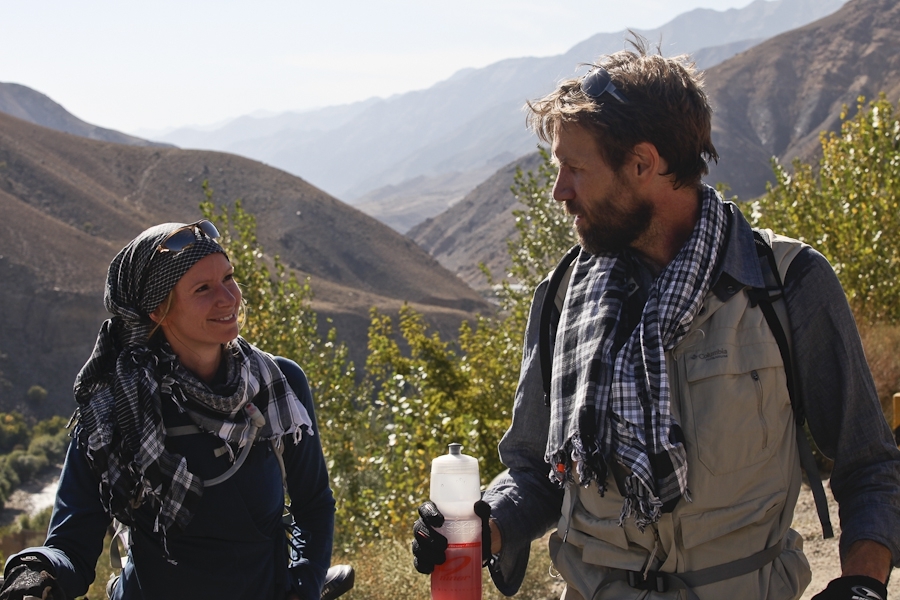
[{"xmin": 682, "ymin": 343, "xmax": 787, "ymax": 475}]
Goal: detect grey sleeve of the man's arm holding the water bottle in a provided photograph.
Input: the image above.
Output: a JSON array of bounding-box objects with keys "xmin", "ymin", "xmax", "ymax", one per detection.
[{"xmin": 484, "ymin": 280, "xmax": 563, "ymax": 596}]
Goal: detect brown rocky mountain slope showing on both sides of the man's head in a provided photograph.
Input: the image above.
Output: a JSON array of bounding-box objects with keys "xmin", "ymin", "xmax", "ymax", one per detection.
[{"xmin": 408, "ymin": 0, "xmax": 900, "ymax": 288}]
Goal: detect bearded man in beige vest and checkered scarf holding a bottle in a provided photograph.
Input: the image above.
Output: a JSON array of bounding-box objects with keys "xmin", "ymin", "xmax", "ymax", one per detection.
[{"xmin": 413, "ymin": 42, "xmax": 900, "ymax": 600}]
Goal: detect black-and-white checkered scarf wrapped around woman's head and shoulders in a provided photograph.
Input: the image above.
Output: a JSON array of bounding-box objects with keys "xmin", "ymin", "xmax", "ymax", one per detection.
[{"xmin": 75, "ymin": 223, "xmax": 312, "ymax": 559}]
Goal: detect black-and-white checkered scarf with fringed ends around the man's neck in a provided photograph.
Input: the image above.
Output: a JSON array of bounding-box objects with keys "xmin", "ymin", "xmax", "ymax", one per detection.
[{"xmin": 545, "ymin": 186, "xmax": 726, "ymax": 529}]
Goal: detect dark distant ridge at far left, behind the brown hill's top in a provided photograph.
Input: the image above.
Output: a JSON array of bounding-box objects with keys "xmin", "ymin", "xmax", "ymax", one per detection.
[{"xmin": 0, "ymin": 82, "xmax": 171, "ymax": 147}]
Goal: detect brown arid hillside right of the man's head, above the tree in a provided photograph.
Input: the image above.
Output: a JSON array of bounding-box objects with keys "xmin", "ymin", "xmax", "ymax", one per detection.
[{"xmin": 706, "ymin": 0, "xmax": 900, "ymax": 199}]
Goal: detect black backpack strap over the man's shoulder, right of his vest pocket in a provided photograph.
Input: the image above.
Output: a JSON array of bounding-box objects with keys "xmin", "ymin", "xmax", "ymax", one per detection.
[{"xmin": 747, "ymin": 229, "xmax": 834, "ymax": 538}]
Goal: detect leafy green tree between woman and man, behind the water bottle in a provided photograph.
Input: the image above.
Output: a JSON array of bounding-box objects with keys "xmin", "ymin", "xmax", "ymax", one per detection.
[{"xmin": 354, "ymin": 149, "xmax": 575, "ymax": 536}]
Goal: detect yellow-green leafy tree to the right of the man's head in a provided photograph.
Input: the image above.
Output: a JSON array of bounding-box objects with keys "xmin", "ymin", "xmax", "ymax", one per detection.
[{"xmin": 752, "ymin": 95, "xmax": 900, "ymax": 324}]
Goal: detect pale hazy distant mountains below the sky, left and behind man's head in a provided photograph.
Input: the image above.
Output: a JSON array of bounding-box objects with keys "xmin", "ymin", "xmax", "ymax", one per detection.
[{"xmin": 151, "ymin": 0, "xmax": 844, "ymax": 231}]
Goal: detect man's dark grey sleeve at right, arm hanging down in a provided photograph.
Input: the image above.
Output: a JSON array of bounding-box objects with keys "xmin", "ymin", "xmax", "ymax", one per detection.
[{"xmin": 784, "ymin": 248, "xmax": 900, "ymax": 566}]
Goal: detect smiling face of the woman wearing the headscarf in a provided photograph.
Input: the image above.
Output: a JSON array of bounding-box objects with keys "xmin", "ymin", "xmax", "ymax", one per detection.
[{"xmin": 150, "ymin": 252, "xmax": 241, "ymax": 366}]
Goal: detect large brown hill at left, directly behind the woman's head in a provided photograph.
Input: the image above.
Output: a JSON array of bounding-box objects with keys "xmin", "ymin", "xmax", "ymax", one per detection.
[{"xmin": 0, "ymin": 114, "xmax": 487, "ymax": 415}]
